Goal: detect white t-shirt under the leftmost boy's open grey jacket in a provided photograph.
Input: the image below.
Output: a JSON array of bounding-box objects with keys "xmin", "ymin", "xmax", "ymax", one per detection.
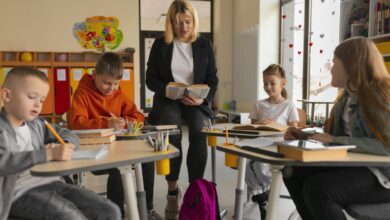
[{"xmin": 12, "ymin": 124, "xmax": 60, "ymax": 201}]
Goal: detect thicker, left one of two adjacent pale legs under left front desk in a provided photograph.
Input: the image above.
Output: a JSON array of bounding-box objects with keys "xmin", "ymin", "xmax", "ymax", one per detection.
[{"xmin": 119, "ymin": 166, "xmax": 139, "ymax": 220}]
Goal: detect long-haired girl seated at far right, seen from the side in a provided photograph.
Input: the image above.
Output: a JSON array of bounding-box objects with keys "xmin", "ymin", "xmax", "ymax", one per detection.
[{"xmin": 283, "ymin": 37, "xmax": 390, "ymax": 220}]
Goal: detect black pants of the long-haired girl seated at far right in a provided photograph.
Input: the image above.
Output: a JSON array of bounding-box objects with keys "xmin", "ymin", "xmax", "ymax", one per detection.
[{"xmin": 283, "ymin": 167, "xmax": 390, "ymax": 220}]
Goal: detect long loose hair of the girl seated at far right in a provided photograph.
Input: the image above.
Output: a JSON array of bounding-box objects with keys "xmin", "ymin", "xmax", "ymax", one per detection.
[{"xmin": 331, "ymin": 37, "xmax": 390, "ymax": 145}]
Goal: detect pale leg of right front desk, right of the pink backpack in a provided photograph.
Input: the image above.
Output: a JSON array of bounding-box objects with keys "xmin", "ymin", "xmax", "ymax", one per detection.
[{"xmin": 265, "ymin": 165, "xmax": 282, "ymax": 220}]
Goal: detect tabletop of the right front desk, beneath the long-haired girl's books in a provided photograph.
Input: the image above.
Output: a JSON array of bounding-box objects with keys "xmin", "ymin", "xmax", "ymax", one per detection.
[{"xmin": 217, "ymin": 145, "xmax": 390, "ymax": 167}]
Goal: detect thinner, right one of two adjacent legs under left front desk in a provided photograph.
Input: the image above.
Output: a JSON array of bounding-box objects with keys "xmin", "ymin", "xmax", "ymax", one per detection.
[{"xmin": 135, "ymin": 163, "xmax": 148, "ymax": 220}]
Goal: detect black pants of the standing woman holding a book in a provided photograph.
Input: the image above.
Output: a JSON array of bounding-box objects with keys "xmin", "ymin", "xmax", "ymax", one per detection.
[{"xmin": 154, "ymin": 101, "xmax": 208, "ymax": 182}]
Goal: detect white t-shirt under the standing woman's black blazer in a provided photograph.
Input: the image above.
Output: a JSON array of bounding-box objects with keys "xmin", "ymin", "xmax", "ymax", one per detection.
[{"xmin": 171, "ymin": 39, "xmax": 194, "ymax": 85}]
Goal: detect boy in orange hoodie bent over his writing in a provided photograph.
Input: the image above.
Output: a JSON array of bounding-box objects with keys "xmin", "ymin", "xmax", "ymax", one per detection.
[{"xmin": 68, "ymin": 52, "xmax": 161, "ymax": 219}]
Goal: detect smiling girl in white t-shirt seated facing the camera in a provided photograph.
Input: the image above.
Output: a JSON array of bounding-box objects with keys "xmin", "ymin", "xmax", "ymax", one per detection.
[{"xmin": 245, "ymin": 64, "xmax": 299, "ymax": 219}]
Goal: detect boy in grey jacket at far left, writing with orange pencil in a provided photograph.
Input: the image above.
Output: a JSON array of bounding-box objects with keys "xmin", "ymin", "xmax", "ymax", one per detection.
[{"xmin": 0, "ymin": 67, "xmax": 120, "ymax": 219}]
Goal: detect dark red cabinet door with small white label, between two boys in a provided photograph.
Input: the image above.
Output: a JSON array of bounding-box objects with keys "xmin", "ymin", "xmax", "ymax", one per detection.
[{"xmin": 54, "ymin": 67, "xmax": 70, "ymax": 115}]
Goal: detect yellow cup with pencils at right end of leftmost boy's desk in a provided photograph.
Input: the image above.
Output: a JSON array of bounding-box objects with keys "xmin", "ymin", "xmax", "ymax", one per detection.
[{"xmin": 147, "ymin": 131, "xmax": 171, "ymax": 176}]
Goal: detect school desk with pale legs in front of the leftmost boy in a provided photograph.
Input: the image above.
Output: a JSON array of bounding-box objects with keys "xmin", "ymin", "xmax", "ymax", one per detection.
[{"xmin": 31, "ymin": 140, "xmax": 179, "ymax": 220}]
